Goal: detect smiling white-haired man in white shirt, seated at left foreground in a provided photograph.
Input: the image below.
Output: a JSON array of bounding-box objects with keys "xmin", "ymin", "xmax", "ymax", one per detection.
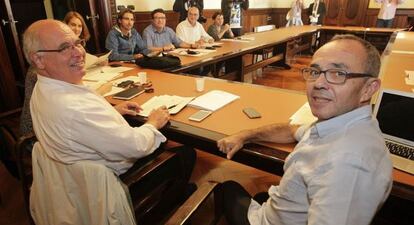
[{"xmin": 23, "ymin": 20, "xmax": 195, "ymax": 224}]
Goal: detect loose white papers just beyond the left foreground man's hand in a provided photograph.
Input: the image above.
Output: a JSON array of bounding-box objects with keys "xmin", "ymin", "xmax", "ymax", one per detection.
[{"xmin": 138, "ymin": 95, "xmax": 194, "ymax": 117}]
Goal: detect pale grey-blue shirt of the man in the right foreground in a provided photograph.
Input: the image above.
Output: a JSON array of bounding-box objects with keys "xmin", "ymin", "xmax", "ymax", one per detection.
[{"xmin": 248, "ymin": 106, "xmax": 392, "ymax": 225}]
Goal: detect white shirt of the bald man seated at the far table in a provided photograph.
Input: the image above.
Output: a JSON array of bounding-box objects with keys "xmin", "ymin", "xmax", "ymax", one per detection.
[{"xmin": 176, "ymin": 19, "xmax": 213, "ymax": 44}]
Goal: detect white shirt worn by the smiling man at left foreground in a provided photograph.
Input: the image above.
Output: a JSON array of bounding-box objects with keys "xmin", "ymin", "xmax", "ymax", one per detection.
[{"xmin": 30, "ymin": 75, "xmax": 166, "ymax": 175}]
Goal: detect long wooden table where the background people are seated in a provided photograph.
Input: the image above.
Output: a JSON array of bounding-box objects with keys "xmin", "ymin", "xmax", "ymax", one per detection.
[{"xmin": 166, "ymin": 25, "xmax": 401, "ymax": 81}]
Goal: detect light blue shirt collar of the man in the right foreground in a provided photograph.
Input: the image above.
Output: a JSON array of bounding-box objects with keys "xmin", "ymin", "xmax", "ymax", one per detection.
[{"xmin": 311, "ymin": 105, "xmax": 372, "ymax": 137}]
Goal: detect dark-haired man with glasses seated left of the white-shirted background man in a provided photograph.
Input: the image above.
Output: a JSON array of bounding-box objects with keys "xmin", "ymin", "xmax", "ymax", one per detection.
[{"xmin": 142, "ymin": 9, "xmax": 193, "ymax": 52}]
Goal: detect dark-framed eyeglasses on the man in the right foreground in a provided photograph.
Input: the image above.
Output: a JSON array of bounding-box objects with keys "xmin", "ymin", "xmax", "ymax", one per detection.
[{"xmin": 302, "ymin": 67, "xmax": 373, "ymax": 84}]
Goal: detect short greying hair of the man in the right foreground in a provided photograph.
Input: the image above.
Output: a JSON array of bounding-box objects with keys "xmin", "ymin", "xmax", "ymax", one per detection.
[{"xmin": 329, "ymin": 34, "xmax": 381, "ymax": 77}]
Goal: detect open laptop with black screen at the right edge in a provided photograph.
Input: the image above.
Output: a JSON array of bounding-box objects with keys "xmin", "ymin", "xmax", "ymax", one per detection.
[{"xmin": 374, "ymin": 90, "xmax": 414, "ymax": 174}]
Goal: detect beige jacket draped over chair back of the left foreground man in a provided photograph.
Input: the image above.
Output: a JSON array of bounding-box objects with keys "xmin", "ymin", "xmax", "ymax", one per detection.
[{"xmin": 30, "ymin": 143, "xmax": 136, "ymax": 225}]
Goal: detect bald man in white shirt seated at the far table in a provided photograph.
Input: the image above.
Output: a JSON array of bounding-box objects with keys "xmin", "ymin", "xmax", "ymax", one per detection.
[{"xmin": 176, "ymin": 6, "xmax": 214, "ymax": 47}]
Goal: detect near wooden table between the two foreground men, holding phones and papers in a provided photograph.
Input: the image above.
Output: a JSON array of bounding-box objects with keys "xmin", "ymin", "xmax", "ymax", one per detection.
[{"xmin": 107, "ymin": 64, "xmax": 414, "ymax": 201}]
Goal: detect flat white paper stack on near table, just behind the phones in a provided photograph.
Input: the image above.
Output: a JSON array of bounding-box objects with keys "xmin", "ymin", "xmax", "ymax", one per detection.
[{"xmin": 188, "ymin": 90, "xmax": 240, "ymax": 111}]
